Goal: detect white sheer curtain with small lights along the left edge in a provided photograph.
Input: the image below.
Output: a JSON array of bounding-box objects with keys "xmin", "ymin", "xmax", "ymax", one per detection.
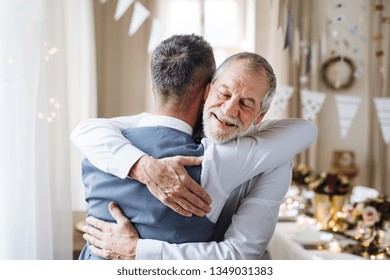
[{"xmin": 0, "ymin": 0, "xmax": 96, "ymax": 259}]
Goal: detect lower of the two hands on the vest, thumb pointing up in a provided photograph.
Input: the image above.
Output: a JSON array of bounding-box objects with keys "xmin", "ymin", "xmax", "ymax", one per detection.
[{"xmin": 82, "ymin": 202, "xmax": 139, "ymax": 260}]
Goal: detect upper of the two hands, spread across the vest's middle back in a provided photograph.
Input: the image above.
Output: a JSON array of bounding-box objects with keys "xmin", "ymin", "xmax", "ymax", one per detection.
[{"xmin": 129, "ymin": 155, "xmax": 211, "ymax": 217}]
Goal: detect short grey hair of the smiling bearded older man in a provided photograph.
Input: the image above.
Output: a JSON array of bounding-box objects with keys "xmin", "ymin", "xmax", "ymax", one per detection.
[{"xmin": 211, "ymin": 52, "xmax": 276, "ymax": 113}]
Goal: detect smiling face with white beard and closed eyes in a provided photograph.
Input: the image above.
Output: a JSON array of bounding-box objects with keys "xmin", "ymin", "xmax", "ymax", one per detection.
[{"xmin": 203, "ymin": 59, "xmax": 268, "ymax": 143}]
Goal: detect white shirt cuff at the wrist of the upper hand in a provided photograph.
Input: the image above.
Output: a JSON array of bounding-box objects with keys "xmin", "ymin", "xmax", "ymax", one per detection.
[{"xmin": 109, "ymin": 144, "xmax": 145, "ymax": 179}]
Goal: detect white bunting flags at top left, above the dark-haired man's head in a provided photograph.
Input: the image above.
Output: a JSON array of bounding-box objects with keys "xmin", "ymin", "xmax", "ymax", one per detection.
[{"xmin": 100, "ymin": 0, "xmax": 163, "ymax": 53}]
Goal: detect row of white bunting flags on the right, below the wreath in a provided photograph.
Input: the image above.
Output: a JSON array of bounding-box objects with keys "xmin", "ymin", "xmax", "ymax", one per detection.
[{"xmin": 271, "ymin": 85, "xmax": 390, "ymax": 144}]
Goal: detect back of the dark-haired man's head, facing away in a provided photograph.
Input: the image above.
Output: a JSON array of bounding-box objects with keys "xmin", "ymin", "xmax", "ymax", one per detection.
[{"xmin": 151, "ymin": 34, "xmax": 216, "ymax": 110}]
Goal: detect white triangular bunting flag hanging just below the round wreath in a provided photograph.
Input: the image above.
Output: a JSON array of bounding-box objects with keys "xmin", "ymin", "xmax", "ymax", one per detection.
[{"xmin": 335, "ymin": 94, "xmax": 362, "ymax": 139}]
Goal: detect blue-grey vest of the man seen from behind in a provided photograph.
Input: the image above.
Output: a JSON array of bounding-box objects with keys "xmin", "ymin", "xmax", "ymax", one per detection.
[{"xmin": 79, "ymin": 126, "xmax": 215, "ymax": 259}]
